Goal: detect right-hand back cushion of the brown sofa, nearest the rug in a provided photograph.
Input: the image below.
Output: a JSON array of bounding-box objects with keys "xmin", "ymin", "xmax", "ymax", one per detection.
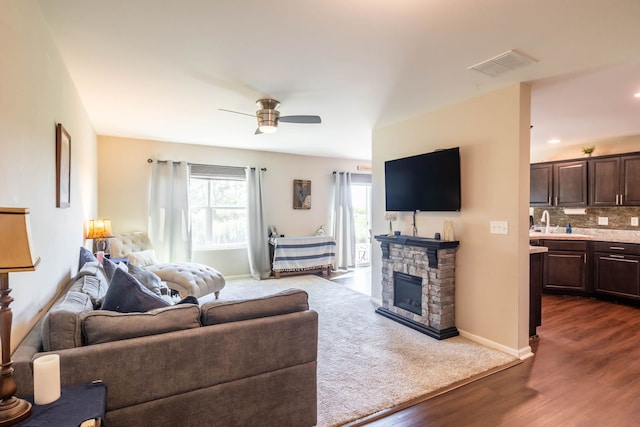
[{"xmin": 200, "ymin": 289, "xmax": 309, "ymax": 326}]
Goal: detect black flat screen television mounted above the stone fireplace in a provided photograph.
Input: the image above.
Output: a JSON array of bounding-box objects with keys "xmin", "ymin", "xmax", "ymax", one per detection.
[{"xmin": 384, "ymin": 147, "xmax": 460, "ymax": 212}]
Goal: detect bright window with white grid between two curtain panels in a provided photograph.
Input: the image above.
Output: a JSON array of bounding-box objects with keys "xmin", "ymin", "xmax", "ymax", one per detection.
[{"xmin": 189, "ymin": 165, "xmax": 247, "ymax": 249}]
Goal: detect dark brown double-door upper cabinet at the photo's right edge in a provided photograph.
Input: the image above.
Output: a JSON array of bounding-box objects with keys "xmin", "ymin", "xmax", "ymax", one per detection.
[{"xmin": 589, "ymin": 155, "xmax": 640, "ymax": 206}]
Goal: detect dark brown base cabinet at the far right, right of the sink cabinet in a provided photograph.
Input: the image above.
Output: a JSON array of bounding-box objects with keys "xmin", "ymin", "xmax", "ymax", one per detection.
[{"xmin": 593, "ymin": 242, "xmax": 640, "ymax": 300}]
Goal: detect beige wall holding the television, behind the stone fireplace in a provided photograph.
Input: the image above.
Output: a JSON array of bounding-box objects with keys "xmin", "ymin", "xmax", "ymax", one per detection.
[{"xmin": 372, "ymin": 85, "xmax": 530, "ymax": 357}]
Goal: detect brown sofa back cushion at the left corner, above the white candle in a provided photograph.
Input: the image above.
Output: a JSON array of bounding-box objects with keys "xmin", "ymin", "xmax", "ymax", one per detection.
[{"xmin": 42, "ymin": 291, "xmax": 93, "ymax": 351}]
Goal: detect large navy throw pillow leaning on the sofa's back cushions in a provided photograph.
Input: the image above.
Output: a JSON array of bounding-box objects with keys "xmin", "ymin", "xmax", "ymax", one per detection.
[{"xmin": 101, "ymin": 268, "xmax": 170, "ymax": 313}]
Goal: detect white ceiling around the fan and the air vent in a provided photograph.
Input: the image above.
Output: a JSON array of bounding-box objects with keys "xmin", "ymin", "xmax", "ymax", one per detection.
[{"xmin": 39, "ymin": 0, "xmax": 640, "ymax": 159}]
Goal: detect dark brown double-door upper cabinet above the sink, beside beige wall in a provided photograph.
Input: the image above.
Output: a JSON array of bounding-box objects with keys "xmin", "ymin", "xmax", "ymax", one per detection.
[{"xmin": 529, "ymin": 160, "xmax": 587, "ymax": 206}]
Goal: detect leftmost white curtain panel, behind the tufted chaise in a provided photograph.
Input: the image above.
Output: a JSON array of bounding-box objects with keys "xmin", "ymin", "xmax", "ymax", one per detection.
[{"xmin": 149, "ymin": 161, "xmax": 191, "ymax": 262}]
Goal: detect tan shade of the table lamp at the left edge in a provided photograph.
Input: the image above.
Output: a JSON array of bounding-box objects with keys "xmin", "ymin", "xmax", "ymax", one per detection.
[{"xmin": 0, "ymin": 208, "xmax": 40, "ymax": 273}]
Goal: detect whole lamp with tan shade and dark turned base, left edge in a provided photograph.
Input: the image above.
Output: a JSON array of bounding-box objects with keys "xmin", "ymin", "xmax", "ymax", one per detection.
[{"xmin": 0, "ymin": 208, "xmax": 40, "ymax": 426}]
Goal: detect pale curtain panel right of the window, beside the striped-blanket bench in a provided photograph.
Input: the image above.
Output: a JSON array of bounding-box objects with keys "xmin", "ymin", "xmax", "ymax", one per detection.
[{"xmin": 246, "ymin": 168, "xmax": 271, "ymax": 280}]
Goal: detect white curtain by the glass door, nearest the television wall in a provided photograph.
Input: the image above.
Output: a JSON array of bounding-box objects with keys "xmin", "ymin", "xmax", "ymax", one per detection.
[{"xmin": 332, "ymin": 172, "xmax": 356, "ymax": 269}]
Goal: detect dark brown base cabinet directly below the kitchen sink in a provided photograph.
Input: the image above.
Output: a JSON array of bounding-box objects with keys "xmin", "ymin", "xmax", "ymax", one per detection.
[{"xmin": 542, "ymin": 240, "xmax": 588, "ymax": 295}]
